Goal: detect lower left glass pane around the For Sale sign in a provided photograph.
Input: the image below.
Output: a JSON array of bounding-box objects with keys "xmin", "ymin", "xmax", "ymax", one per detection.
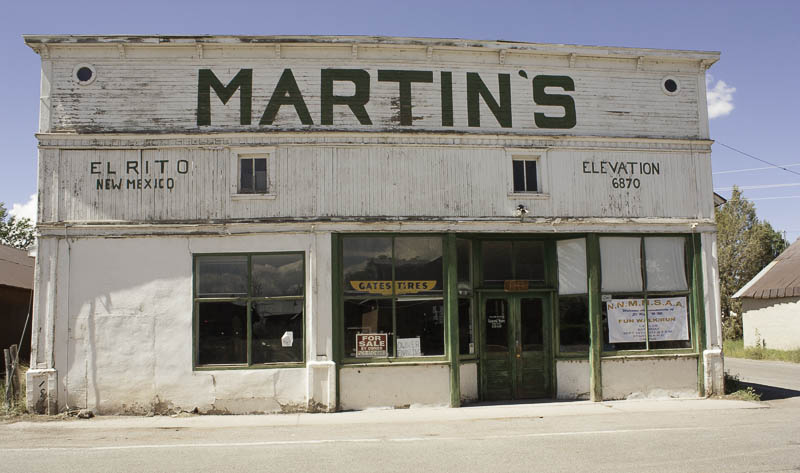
[{"xmin": 344, "ymin": 299, "xmax": 394, "ymax": 358}]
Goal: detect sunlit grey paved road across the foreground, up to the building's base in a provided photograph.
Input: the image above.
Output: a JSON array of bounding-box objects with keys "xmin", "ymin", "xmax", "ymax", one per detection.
[{"xmin": 0, "ymin": 398, "xmax": 800, "ymax": 473}]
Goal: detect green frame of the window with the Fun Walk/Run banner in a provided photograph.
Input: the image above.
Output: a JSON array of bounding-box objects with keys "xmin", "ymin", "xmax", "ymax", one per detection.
[{"xmin": 598, "ymin": 234, "xmax": 698, "ymax": 356}]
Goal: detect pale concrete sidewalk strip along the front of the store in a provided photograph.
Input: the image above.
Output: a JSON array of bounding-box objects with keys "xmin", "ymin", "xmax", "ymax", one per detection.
[{"xmin": 0, "ymin": 399, "xmax": 769, "ymax": 430}]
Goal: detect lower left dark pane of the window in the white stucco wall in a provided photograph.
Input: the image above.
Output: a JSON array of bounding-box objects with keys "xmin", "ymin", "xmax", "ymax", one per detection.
[{"xmin": 197, "ymin": 302, "xmax": 247, "ymax": 365}]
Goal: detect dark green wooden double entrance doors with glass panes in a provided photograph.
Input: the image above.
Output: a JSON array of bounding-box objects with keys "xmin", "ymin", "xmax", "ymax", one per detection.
[{"xmin": 481, "ymin": 294, "xmax": 549, "ymax": 400}]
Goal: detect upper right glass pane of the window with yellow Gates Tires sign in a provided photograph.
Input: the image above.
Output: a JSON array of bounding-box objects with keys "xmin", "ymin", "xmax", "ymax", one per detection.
[{"xmin": 394, "ymin": 237, "xmax": 443, "ymax": 295}]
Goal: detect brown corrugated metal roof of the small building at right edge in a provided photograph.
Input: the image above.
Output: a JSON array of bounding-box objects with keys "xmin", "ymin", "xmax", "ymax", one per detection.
[{"xmin": 733, "ymin": 239, "xmax": 800, "ymax": 299}]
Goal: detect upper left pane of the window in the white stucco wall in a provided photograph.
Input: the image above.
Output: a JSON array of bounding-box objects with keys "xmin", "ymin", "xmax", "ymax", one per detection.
[{"xmin": 197, "ymin": 256, "xmax": 247, "ymax": 297}]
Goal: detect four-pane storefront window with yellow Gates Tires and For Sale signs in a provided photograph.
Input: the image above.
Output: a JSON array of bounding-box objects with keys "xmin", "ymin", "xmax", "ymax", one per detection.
[{"xmin": 342, "ymin": 236, "xmax": 445, "ymax": 359}]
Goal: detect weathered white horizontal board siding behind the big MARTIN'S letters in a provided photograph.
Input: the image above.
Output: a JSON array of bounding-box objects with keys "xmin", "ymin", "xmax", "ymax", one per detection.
[{"xmin": 41, "ymin": 56, "xmax": 705, "ymax": 139}]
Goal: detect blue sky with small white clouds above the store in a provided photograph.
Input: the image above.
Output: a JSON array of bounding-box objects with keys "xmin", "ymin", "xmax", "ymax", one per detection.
[{"xmin": 0, "ymin": 0, "xmax": 800, "ymax": 241}]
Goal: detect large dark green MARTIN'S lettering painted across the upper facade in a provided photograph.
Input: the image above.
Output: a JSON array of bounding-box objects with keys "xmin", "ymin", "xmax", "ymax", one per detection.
[{"xmin": 197, "ymin": 68, "xmax": 577, "ymax": 129}]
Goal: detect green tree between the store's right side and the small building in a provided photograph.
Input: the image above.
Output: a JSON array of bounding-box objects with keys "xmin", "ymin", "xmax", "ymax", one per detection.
[{"xmin": 715, "ymin": 186, "xmax": 789, "ymax": 339}]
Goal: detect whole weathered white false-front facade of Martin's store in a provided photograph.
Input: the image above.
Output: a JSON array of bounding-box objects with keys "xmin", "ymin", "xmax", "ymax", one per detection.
[{"xmin": 25, "ymin": 36, "xmax": 722, "ymax": 413}]
